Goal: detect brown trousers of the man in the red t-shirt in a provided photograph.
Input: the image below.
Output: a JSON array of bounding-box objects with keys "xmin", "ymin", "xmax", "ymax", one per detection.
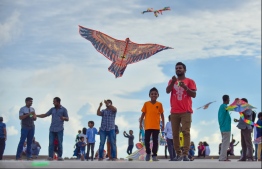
[{"xmin": 171, "ymin": 112, "xmax": 192, "ymax": 156}]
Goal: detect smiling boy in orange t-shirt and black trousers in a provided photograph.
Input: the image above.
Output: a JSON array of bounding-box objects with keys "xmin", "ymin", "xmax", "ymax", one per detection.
[{"xmin": 140, "ymin": 87, "xmax": 165, "ymax": 161}]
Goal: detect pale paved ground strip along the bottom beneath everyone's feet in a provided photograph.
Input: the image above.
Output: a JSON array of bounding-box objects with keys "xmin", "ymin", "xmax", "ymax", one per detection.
[{"xmin": 0, "ymin": 160, "xmax": 261, "ymax": 169}]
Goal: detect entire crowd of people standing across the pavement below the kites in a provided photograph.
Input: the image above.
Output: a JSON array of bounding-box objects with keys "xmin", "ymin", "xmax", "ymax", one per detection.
[{"xmin": 0, "ymin": 62, "xmax": 262, "ymax": 161}]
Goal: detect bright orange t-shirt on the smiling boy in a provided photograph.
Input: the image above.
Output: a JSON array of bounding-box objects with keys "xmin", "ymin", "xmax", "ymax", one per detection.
[{"xmin": 141, "ymin": 101, "xmax": 164, "ymax": 130}]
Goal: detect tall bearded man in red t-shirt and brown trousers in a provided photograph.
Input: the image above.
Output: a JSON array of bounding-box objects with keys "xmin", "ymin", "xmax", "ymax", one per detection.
[{"xmin": 166, "ymin": 62, "xmax": 197, "ymax": 161}]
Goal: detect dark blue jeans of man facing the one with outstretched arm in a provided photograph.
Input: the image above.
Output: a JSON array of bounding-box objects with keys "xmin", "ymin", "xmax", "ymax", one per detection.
[{"xmin": 16, "ymin": 128, "xmax": 35, "ymax": 159}]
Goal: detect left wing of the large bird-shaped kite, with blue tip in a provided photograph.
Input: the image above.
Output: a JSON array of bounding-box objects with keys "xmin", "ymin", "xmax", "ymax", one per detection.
[{"xmin": 79, "ymin": 25, "xmax": 126, "ymax": 62}]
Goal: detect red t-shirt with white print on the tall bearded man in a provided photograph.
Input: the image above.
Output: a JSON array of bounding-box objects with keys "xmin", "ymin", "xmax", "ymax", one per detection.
[{"xmin": 168, "ymin": 78, "xmax": 197, "ymax": 113}]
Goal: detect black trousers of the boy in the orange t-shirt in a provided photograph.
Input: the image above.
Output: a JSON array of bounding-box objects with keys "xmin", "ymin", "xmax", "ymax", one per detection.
[{"xmin": 145, "ymin": 129, "xmax": 159, "ymax": 156}]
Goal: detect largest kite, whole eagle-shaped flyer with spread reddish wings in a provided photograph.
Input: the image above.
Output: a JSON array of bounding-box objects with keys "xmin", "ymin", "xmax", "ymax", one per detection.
[{"xmin": 79, "ymin": 26, "xmax": 173, "ymax": 78}]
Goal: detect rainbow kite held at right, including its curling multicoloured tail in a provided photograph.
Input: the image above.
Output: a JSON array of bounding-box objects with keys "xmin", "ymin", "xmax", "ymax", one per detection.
[{"xmin": 226, "ymin": 98, "xmax": 262, "ymax": 128}]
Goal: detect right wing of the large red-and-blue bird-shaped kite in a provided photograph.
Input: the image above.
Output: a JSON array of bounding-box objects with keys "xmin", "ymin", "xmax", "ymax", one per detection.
[{"xmin": 123, "ymin": 41, "xmax": 173, "ymax": 64}]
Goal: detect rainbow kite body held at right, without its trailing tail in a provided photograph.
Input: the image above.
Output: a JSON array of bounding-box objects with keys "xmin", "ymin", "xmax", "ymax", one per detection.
[{"xmin": 226, "ymin": 98, "xmax": 256, "ymax": 112}]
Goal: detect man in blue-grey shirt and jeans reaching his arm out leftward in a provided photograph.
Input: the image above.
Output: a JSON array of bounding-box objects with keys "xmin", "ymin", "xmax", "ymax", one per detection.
[{"xmin": 37, "ymin": 97, "xmax": 69, "ymax": 161}]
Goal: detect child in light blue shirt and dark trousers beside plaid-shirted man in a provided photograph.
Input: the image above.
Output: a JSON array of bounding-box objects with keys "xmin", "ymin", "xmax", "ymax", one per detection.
[{"xmin": 86, "ymin": 121, "xmax": 98, "ymax": 161}]
